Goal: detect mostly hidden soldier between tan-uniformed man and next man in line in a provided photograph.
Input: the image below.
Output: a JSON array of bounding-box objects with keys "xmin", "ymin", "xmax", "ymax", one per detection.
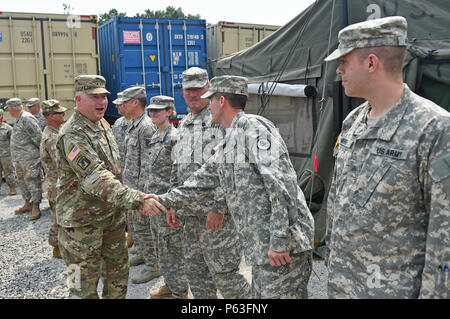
[{"xmin": 111, "ymin": 92, "xmax": 136, "ymax": 253}]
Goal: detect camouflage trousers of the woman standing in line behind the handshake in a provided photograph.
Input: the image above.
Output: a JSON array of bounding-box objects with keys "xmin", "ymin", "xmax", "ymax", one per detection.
[{"xmin": 156, "ymin": 214, "xmax": 189, "ymax": 298}]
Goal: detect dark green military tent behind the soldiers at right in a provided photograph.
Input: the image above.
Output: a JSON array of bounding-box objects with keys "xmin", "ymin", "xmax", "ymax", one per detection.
[{"xmin": 208, "ymin": 0, "xmax": 450, "ymax": 255}]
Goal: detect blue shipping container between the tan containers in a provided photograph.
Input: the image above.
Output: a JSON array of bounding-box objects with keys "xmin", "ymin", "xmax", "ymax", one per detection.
[{"xmin": 98, "ymin": 17, "xmax": 208, "ymax": 123}]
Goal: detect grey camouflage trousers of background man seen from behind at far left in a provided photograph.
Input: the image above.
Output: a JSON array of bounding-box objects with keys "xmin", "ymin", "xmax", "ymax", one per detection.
[{"xmin": 14, "ymin": 159, "xmax": 42, "ymax": 203}]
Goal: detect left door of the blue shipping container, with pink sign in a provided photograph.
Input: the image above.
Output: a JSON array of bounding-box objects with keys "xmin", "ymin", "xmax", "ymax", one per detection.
[{"xmin": 118, "ymin": 19, "xmax": 162, "ymax": 102}]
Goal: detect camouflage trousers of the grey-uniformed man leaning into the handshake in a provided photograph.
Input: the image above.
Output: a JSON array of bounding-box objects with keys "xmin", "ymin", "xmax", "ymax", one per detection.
[{"xmin": 252, "ymin": 250, "xmax": 312, "ymax": 299}]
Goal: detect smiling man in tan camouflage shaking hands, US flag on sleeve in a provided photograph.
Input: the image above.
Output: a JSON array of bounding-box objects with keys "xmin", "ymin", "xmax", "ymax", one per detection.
[{"xmin": 56, "ymin": 75, "xmax": 165, "ymax": 298}]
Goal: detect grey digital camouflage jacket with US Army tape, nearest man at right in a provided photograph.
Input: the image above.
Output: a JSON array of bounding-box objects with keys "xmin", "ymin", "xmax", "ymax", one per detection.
[{"xmin": 327, "ymin": 87, "xmax": 450, "ymax": 298}]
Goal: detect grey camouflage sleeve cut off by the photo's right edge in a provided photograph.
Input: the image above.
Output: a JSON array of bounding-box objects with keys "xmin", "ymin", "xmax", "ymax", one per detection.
[{"xmin": 420, "ymin": 127, "xmax": 450, "ymax": 299}]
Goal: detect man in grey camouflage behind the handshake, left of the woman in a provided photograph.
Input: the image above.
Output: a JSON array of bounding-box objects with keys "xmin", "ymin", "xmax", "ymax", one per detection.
[{"xmin": 122, "ymin": 86, "xmax": 160, "ymax": 284}]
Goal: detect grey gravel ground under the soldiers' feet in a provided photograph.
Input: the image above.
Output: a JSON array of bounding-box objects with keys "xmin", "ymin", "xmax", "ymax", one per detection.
[{"xmin": 0, "ymin": 183, "xmax": 327, "ymax": 299}]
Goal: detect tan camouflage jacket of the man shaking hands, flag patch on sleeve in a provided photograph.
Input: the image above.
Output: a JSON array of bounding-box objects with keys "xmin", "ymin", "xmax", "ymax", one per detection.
[{"xmin": 56, "ymin": 111, "xmax": 143, "ymax": 227}]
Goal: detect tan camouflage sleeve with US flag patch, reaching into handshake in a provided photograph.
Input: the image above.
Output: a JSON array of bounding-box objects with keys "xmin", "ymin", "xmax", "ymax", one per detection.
[{"xmin": 58, "ymin": 134, "xmax": 143, "ymax": 209}]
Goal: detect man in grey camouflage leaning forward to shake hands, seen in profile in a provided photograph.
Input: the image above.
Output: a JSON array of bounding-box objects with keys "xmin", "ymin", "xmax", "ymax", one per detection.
[{"xmin": 148, "ymin": 76, "xmax": 314, "ymax": 299}]
